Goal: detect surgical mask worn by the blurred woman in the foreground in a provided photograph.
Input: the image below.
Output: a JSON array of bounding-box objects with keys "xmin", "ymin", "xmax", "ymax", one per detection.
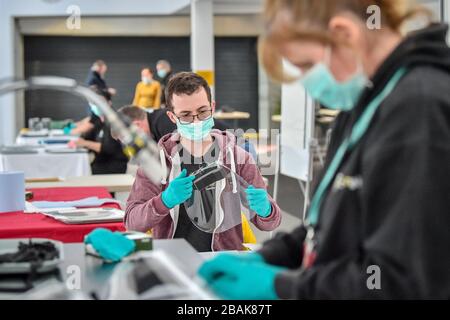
[{"xmin": 300, "ymin": 48, "xmax": 369, "ymax": 111}]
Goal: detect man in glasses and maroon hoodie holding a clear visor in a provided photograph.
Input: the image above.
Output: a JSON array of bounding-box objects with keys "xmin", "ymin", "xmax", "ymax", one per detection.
[{"xmin": 125, "ymin": 72, "xmax": 281, "ymax": 252}]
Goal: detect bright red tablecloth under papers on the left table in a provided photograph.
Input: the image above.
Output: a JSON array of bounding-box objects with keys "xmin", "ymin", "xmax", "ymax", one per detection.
[{"xmin": 0, "ymin": 187, "xmax": 125, "ymax": 243}]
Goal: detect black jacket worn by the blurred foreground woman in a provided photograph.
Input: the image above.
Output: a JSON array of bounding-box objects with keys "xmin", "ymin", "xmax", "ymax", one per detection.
[{"xmin": 260, "ymin": 24, "xmax": 450, "ymax": 299}]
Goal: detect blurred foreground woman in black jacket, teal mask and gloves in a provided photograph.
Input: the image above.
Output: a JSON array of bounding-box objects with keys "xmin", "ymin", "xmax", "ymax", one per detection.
[{"xmin": 199, "ymin": 0, "xmax": 450, "ymax": 299}]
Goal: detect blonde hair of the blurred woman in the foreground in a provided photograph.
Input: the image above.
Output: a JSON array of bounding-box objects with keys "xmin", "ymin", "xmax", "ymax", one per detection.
[{"xmin": 259, "ymin": 0, "xmax": 430, "ymax": 81}]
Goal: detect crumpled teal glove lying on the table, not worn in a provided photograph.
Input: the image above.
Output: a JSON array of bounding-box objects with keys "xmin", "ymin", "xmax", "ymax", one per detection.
[{"xmin": 84, "ymin": 228, "xmax": 136, "ymax": 262}]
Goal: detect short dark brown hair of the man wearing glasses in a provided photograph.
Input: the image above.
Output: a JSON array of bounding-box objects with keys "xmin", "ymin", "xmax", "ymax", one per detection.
[{"xmin": 164, "ymin": 72, "xmax": 211, "ymax": 111}]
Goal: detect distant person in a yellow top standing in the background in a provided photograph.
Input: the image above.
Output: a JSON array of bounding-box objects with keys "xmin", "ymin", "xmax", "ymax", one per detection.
[{"xmin": 133, "ymin": 68, "xmax": 161, "ymax": 109}]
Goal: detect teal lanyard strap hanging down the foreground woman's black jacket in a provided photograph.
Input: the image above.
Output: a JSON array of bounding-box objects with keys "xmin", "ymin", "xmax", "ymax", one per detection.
[{"xmin": 307, "ymin": 68, "xmax": 406, "ymax": 227}]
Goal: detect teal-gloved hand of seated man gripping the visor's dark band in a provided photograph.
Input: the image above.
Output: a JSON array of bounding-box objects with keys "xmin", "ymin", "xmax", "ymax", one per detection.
[{"xmin": 161, "ymin": 169, "xmax": 195, "ymax": 209}]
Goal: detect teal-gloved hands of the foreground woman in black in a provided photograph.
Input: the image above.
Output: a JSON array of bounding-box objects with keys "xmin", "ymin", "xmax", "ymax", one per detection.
[{"xmin": 198, "ymin": 254, "xmax": 285, "ymax": 300}]
